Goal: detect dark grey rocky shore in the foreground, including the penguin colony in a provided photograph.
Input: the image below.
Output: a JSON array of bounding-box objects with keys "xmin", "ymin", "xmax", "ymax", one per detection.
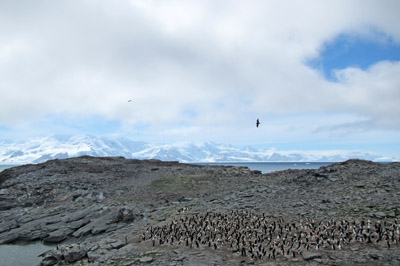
[{"xmin": 0, "ymin": 156, "xmax": 400, "ymax": 265}]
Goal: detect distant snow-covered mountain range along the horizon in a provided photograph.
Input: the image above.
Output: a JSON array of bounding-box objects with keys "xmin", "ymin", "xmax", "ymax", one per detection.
[{"xmin": 0, "ymin": 135, "xmax": 397, "ymax": 165}]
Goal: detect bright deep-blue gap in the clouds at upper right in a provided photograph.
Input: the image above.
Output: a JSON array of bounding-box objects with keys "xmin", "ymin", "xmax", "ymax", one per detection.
[{"xmin": 307, "ymin": 33, "xmax": 400, "ymax": 81}]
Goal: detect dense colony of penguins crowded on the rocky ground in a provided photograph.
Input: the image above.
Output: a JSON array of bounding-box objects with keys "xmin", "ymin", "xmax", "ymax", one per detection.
[{"xmin": 140, "ymin": 211, "xmax": 400, "ymax": 259}]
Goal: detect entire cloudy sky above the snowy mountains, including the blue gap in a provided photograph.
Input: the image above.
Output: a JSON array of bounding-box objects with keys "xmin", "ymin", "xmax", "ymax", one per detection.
[{"xmin": 0, "ymin": 0, "xmax": 400, "ymax": 157}]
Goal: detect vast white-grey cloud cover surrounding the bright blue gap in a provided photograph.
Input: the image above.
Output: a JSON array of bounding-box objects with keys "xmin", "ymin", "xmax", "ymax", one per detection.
[{"xmin": 0, "ymin": 0, "xmax": 400, "ymax": 145}]
